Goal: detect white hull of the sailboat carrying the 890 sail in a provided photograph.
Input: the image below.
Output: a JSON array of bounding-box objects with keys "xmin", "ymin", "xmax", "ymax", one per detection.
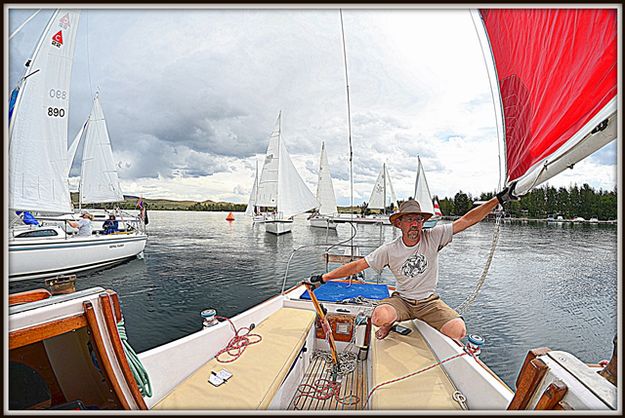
[{"xmin": 9, "ymin": 234, "xmax": 147, "ymax": 282}]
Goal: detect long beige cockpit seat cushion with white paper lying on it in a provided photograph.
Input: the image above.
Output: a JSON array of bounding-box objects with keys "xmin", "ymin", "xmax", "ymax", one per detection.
[{"xmin": 154, "ymin": 308, "xmax": 316, "ymax": 410}]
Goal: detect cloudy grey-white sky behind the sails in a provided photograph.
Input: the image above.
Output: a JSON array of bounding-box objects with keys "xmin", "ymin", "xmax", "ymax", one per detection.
[{"xmin": 5, "ymin": 9, "xmax": 617, "ymax": 205}]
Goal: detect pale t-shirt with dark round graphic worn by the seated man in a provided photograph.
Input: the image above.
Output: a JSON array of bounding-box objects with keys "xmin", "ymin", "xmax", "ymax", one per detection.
[{"xmin": 365, "ymin": 223, "xmax": 453, "ymax": 299}]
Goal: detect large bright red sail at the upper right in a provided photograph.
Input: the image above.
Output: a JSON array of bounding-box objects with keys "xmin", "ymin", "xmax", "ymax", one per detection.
[{"xmin": 480, "ymin": 9, "xmax": 617, "ymax": 181}]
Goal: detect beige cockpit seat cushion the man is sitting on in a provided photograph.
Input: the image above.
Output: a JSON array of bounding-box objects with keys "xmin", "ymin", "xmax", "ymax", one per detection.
[{"xmin": 370, "ymin": 321, "xmax": 461, "ymax": 410}]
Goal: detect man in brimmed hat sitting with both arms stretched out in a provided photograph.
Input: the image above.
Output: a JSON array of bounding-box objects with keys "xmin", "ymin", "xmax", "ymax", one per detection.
[{"xmin": 310, "ymin": 184, "xmax": 518, "ymax": 340}]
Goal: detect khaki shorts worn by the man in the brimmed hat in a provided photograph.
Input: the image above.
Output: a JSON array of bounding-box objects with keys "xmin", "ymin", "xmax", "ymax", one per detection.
[{"xmin": 378, "ymin": 292, "xmax": 462, "ymax": 331}]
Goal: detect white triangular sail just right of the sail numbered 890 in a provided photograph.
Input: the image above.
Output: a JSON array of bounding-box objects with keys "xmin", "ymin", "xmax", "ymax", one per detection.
[{"xmin": 80, "ymin": 94, "xmax": 124, "ymax": 203}]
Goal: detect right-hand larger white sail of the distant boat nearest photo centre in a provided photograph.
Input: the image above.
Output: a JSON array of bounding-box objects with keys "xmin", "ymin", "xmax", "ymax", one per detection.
[{"xmin": 277, "ymin": 134, "xmax": 319, "ymax": 219}]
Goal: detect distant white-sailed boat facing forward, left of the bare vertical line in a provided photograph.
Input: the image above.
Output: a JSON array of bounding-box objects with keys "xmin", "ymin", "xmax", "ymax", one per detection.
[{"xmin": 255, "ymin": 112, "xmax": 319, "ymax": 235}]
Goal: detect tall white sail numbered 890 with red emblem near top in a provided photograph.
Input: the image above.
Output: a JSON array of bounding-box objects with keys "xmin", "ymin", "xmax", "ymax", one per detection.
[{"xmin": 9, "ymin": 10, "xmax": 80, "ymax": 213}]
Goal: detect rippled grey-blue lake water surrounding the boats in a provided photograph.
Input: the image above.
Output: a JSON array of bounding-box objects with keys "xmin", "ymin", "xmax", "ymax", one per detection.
[{"xmin": 10, "ymin": 211, "xmax": 617, "ymax": 389}]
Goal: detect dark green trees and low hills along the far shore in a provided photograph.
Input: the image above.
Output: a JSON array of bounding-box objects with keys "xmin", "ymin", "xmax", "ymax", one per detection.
[{"xmin": 72, "ymin": 184, "xmax": 618, "ymax": 220}]
